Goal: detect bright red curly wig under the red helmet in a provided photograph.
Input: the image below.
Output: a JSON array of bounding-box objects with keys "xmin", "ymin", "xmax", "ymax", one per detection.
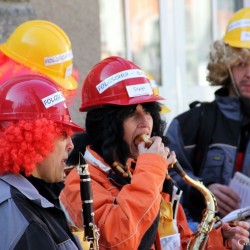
[{"xmin": 0, "ymin": 118, "xmax": 72, "ymax": 176}]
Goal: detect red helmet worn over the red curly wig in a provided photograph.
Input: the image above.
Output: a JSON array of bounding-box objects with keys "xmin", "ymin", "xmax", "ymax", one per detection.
[{"xmin": 0, "ymin": 75, "xmax": 83, "ymax": 131}]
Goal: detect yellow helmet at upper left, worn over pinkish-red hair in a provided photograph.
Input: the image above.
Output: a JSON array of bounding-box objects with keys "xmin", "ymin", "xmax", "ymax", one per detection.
[{"xmin": 0, "ymin": 20, "xmax": 78, "ymax": 90}]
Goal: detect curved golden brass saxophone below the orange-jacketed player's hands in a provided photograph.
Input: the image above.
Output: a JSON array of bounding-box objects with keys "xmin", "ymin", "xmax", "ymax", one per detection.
[{"xmin": 173, "ymin": 160, "xmax": 219, "ymax": 250}]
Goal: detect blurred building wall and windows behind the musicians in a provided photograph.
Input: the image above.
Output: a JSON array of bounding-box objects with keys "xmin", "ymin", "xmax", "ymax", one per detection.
[{"xmin": 0, "ymin": 0, "xmax": 250, "ymax": 127}]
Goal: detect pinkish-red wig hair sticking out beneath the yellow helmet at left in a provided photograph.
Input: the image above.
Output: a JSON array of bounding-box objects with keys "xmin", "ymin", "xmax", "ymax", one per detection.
[{"xmin": 0, "ymin": 51, "xmax": 79, "ymax": 101}]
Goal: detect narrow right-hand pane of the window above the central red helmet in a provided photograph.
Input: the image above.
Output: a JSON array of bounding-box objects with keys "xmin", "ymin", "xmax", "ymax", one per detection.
[{"xmin": 127, "ymin": 0, "xmax": 161, "ymax": 84}]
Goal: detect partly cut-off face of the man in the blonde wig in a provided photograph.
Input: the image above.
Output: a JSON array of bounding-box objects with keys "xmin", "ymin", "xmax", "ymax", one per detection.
[{"xmin": 232, "ymin": 63, "xmax": 250, "ymax": 98}]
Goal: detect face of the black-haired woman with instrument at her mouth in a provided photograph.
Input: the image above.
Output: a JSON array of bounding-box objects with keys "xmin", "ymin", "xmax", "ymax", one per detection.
[{"xmin": 123, "ymin": 104, "xmax": 153, "ymax": 159}]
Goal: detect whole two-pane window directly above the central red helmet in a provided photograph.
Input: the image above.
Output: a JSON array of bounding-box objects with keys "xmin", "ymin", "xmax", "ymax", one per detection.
[{"xmin": 99, "ymin": 0, "xmax": 161, "ymax": 84}]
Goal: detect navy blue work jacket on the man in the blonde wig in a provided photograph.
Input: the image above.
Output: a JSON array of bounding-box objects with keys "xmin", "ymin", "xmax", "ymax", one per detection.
[{"xmin": 166, "ymin": 88, "xmax": 250, "ymax": 221}]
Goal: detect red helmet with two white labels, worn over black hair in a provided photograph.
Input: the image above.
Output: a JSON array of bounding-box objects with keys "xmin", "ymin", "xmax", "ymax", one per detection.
[{"xmin": 79, "ymin": 56, "xmax": 165, "ymax": 111}]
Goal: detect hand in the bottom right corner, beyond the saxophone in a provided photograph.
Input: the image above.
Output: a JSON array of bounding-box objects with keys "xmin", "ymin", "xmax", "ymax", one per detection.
[{"xmin": 221, "ymin": 221, "xmax": 250, "ymax": 250}]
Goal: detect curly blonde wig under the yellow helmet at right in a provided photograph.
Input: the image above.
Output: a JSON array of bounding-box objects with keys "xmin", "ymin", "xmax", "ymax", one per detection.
[{"xmin": 207, "ymin": 40, "xmax": 250, "ymax": 86}]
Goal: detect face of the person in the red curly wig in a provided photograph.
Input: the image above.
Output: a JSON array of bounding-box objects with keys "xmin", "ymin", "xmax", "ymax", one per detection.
[{"xmin": 32, "ymin": 135, "xmax": 74, "ymax": 183}]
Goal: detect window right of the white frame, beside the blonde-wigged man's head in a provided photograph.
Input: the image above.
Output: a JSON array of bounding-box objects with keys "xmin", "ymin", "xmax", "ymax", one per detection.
[{"xmin": 184, "ymin": 0, "xmax": 243, "ymax": 86}]
